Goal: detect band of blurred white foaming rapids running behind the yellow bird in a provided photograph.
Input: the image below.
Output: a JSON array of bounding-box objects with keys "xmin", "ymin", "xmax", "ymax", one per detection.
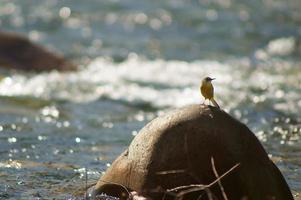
[{"xmin": 0, "ymin": 54, "xmax": 301, "ymax": 113}]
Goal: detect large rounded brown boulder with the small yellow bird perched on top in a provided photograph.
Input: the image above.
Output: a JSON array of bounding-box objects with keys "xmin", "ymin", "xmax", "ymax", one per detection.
[{"xmin": 94, "ymin": 105, "xmax": 293, "ymax": 200}]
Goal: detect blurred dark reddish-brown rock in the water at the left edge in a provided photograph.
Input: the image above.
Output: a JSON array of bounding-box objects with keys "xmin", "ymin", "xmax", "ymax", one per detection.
[{"xmin": 0, "ymin": 32, "xmax": 76, "ymax": 71}]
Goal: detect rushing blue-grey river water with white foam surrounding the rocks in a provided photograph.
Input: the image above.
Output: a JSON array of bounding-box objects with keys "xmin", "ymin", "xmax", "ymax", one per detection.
[{"xmin": 0, "ymin": 0, "xmax": 301, "ymax": 199}]
